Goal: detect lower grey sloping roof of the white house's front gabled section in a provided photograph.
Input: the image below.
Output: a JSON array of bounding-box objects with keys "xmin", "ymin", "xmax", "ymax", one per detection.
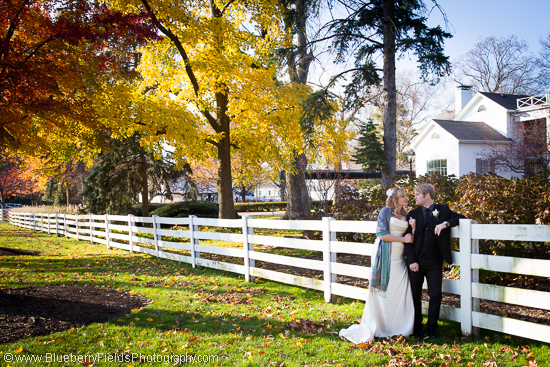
[{"xmin": 433, "ymin": 120, "xmax": 512, "ymax": 141}]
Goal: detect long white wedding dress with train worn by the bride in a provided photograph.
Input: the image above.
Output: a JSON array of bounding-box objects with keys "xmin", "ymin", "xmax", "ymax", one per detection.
[{"xmin": 340, "ymin": 217, "xmax": 414, "ymax": 344}]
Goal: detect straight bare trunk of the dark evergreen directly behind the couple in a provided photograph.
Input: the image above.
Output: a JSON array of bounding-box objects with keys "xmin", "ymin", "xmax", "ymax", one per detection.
[{"xmin": 382, "ymin": 0, "xmax": 397, "ymax": 188}]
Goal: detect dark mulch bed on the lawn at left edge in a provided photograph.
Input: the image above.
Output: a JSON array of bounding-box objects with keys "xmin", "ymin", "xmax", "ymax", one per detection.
[{"xmin": 0, "ymin": 285, "xmax": 150, "ymax": 344}]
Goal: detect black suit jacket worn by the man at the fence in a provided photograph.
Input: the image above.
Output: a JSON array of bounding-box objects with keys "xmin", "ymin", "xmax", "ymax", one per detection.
[{"xmin": 405, "ymin": 204, "xmax": 466, "ymax": 265}]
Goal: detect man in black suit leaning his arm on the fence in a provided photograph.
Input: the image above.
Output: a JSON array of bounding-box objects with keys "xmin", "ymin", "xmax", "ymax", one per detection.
[{"xmin": 405, "ymin": 183, "xmax": 466, "ymax": 339}]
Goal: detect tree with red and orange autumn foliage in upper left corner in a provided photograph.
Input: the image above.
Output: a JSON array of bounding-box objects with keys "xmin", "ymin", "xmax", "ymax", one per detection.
[{"xmin": 0, "ymin": 0, "xmax": 158, "ymax": 157}]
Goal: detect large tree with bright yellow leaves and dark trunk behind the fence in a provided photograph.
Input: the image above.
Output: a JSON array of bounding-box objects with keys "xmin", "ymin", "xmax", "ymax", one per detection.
[{"xmin": 106, "ymin": 0, "xmax": 305, "ymax": 218}]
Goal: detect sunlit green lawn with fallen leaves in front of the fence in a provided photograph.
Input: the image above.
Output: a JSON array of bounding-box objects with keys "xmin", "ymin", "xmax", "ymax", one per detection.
[{"xmin": 0, "ymin": 222, "xmax": 550, "ymax": 367}]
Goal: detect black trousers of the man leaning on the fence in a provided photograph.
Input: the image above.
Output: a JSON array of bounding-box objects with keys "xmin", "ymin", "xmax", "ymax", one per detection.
[{"xmin": 409, "ymin": 258, "xmax": 443, "ymax": 335}]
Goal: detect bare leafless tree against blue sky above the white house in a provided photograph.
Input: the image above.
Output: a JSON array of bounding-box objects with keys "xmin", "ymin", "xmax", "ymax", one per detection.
[{"xmin": 455, "ymin": 36, "xmax": 541, "ymax": 94}]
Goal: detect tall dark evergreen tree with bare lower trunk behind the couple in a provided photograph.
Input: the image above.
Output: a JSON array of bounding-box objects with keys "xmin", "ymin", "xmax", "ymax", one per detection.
[{"xmin": 327, "ymin": 0, "xmax": 451, "ymax": 186}]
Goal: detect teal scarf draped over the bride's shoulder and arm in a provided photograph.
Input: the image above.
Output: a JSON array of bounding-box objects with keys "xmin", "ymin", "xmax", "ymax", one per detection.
[{"xmin": 370, "ymin": 207, "xmax": 392, "ymax": 297}]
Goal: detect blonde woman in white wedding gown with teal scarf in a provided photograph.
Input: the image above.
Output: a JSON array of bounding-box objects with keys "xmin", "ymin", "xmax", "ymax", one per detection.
[{"xmin": 340, "ymin": 188, "xmax": 414, "ymax": 344}]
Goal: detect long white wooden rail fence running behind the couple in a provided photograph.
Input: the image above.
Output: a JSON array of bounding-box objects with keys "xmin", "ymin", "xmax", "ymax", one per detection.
[{"xmin": 9, "ymin": 212, "xmax": 550, "ymax": 342}]
